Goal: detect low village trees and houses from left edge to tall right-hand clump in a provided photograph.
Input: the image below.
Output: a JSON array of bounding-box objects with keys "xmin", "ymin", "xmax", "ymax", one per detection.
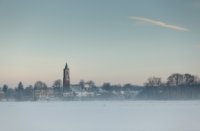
[{"xmin": 0, "ymin": 80, "xmax": 143, "ymax": 101}]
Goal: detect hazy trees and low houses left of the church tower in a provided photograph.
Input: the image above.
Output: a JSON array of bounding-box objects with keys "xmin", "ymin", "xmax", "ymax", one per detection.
[{"xmin": 0, "ymin": 80, "xmax": 62, "ymax": 101}]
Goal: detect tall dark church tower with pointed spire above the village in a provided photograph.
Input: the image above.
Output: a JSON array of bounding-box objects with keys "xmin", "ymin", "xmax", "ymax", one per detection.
[{"xmin": 63, "ymin": 63, "xmax": 70, "ymax": 92}]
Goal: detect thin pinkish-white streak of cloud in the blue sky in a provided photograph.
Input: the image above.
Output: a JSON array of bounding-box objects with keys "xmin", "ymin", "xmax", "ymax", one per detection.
[{"xmin": 129, "ymin": 16, "xmax": 189, "ymax": 31}]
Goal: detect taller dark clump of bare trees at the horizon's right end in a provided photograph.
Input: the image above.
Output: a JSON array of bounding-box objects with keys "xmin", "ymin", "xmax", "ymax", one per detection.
[{"xmin": 137, "ymin": 73, "xmax": 200, "ymax": 100}]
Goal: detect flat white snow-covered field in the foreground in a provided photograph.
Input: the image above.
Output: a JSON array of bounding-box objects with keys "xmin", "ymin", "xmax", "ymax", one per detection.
[{"xmin": 0, "ymin": 101, "xmax": 200, "ymax": 131}]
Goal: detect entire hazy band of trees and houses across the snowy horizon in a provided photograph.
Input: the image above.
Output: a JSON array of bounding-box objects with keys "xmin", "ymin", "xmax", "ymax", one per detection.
[{"xmin": 0, "ymin": 73, "xmax": 200, "ymax": 101}]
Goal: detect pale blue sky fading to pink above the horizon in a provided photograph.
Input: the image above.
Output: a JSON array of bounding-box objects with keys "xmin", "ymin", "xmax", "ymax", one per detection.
[{"xmin": 0, "ymin": 0, "xmax": 200, "ymax": 87}]
